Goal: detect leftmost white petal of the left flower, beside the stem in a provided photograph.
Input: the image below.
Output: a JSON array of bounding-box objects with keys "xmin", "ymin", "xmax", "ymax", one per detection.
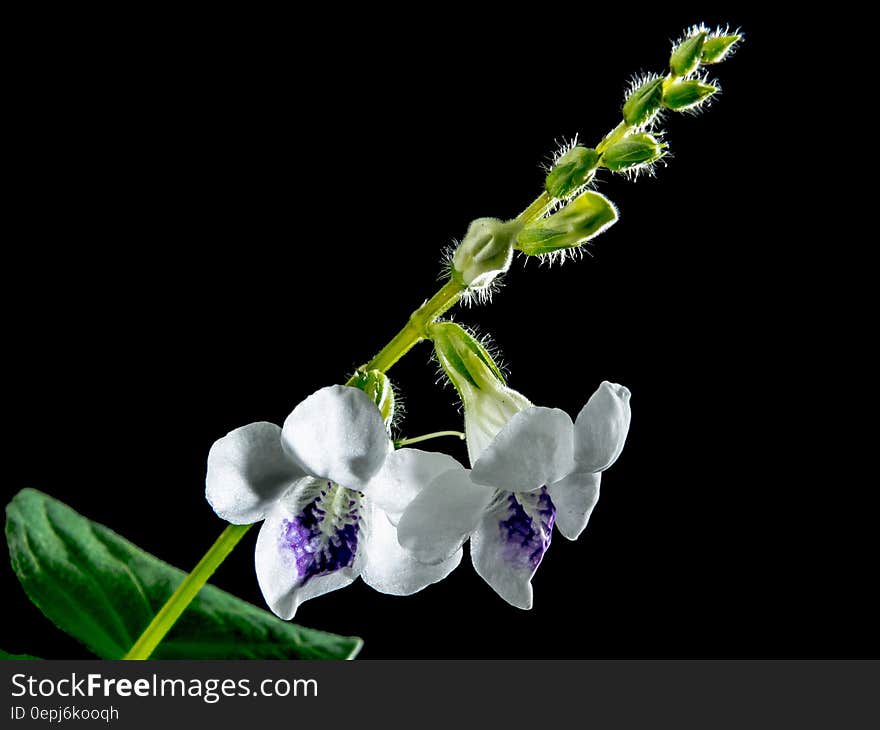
[{"xmin": 205, "ymin": 421, "xmax": 303, "ymax": 525}]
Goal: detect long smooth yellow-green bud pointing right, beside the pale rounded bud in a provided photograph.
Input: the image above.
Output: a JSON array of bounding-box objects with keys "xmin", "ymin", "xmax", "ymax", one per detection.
[{"xmin": 516, "ymin": 190, "xmax": 617, "ymax": 256}]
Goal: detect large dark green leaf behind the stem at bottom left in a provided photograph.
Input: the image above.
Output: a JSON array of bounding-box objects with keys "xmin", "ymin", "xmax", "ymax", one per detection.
[{"xmin": 6, "ymin": 489, "xmax": 363, "ymax": 659}]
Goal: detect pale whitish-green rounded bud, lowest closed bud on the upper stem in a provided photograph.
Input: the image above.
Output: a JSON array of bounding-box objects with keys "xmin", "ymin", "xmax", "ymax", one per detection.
[{"xmin": 452, "ymin": 218, "xmax": 522, "ymax": 289}]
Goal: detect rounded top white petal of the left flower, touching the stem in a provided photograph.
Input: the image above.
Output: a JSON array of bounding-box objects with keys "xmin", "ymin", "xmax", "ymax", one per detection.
[{"xmin": 282, "ymin": 385, "xmax": 391, "ymax": 489}]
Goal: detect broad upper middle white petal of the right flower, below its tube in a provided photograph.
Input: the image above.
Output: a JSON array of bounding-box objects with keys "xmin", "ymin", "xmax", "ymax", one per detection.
[{"xmin": 471, "ymin": 406, "xmax": 574, "ymax": 492}]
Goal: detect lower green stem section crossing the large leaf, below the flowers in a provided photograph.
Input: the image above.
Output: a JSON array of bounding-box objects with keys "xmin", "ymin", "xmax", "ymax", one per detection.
[{"xmin": 122, "ymin": 525, "xmax": 251, "ymax": 659}]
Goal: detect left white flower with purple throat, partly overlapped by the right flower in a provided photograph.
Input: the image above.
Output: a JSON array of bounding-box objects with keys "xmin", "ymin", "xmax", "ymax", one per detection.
[{"xmin": 206, "ymin": 385, "xmax": 461, "ymax": 619}]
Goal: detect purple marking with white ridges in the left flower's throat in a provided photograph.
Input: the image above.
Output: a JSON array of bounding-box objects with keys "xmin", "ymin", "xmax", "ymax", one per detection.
[{"xmin": 281, "ymin": 485, "xmax": 359, "ymax": 585}]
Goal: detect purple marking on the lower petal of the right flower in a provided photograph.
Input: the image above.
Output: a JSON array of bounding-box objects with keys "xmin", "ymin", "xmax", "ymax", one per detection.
[{"xmin": 498, "ymin": 487, "xmax": 556, "ymax": 570}]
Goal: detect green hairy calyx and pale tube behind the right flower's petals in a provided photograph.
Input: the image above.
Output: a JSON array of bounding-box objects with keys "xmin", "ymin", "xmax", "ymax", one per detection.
[{"xmin": 428, "ymin": 322, "xmax": 532, "ymax": 464}]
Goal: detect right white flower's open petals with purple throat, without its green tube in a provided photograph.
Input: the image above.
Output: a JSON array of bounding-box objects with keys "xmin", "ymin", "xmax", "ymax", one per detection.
[{"xmin": 398, "ymin": 381, "xmax": 630, "ymax": 609}]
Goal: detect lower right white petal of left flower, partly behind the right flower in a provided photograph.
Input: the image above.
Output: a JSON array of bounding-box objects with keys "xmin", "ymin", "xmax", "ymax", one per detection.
[{"xmin": 361, "ymin": 505, "xmax": 462, "ymax": 596}]
